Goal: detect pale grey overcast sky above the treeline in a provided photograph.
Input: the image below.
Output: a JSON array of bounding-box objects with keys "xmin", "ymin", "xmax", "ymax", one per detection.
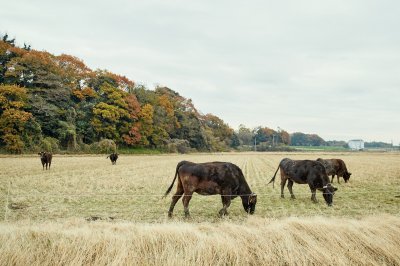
[{"xmin": 0, "ymin": 0, "xmax": 400, "ymax": 145}]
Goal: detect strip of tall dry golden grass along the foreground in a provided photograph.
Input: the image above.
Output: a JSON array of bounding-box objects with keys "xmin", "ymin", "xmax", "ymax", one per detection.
[{"xmin": 0, "ymin": 215, "xmax": 400, "ymax": 265}]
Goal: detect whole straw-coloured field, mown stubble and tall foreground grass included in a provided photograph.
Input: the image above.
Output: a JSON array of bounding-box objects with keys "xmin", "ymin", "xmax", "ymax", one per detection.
[{"xmin": 0, "ymin": 152, "xmax": 400, "ymax": 265}]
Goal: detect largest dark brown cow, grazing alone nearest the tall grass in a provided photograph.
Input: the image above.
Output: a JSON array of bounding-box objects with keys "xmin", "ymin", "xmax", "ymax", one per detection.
[{"xmin": 163, "ymin": 161, "xmax": 257, "ymax": 217}]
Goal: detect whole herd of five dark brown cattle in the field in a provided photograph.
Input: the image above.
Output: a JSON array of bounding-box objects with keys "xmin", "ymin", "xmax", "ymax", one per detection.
[{"xmin": 38, "ymin": 152, "xmax": 351, "ymax": 217}]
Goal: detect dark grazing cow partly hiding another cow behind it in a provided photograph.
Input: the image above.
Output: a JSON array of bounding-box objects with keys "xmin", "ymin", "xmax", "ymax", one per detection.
[{"xmin": 268, "ymin": 158, "xmax": 337, "ymax": 206}]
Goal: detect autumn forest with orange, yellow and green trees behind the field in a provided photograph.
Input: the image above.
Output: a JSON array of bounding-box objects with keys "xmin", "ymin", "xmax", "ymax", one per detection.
[{"xmin": 0, "ymin": 34, "xmax": 343, "ymax": 153}]
